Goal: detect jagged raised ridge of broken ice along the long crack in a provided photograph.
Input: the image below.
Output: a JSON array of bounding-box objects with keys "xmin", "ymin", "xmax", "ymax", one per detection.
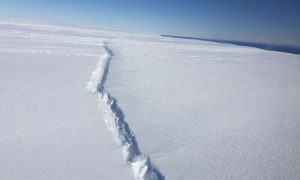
[{"xmin": 87, "ymin": 42, "xmax": 165, "ymax": 180}]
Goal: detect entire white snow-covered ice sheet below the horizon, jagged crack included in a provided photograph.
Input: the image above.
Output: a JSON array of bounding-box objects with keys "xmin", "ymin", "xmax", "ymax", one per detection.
[{"xmin": 0, "ymin": 21, "xmax": 300, "ymax": 180}]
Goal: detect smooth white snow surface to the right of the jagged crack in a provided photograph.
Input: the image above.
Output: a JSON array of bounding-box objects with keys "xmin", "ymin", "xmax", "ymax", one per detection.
[{"xmin": 106, "ymin": 38, "xmax": 300, "ymax": 180}]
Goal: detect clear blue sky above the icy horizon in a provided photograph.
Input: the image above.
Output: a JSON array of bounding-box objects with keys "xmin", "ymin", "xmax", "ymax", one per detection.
[{"xmin": 0, "ymin": 0, "xmax": 300, "ymax": 47}]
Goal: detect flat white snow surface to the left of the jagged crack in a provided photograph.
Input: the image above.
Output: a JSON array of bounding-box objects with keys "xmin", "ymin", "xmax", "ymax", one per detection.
[{"xmin": 0, "ymin": 21, "xmax": 133, "ymax": 180}]
